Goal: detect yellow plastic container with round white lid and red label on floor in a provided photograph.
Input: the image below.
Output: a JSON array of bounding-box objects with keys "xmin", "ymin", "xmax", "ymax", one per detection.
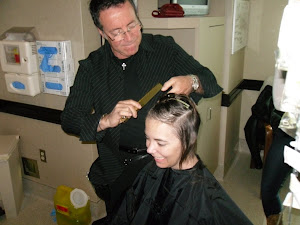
[{"xmin": 54, "ymin": 185, "xmax": 91, "ymax": 225}]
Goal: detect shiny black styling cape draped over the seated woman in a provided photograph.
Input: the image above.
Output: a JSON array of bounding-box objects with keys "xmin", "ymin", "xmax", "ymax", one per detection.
[{"xmin": 110, "ymin": 156, "xmax": 252, "ymax": 225}]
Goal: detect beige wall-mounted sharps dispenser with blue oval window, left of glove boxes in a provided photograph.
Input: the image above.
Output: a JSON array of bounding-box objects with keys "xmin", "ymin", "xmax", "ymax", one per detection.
[{"xmin": 0, "ymin": 27, "xmax": 41, "ymax": 96}]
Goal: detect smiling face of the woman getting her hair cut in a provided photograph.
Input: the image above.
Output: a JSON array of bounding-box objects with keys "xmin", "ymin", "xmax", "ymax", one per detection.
[{"xmin": 145, "ymin": 118, "xmax": 182, "ymax": 169}]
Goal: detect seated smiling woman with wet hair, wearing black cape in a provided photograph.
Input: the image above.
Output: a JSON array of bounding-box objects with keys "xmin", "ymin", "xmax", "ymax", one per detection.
[{"xmin": 110, "ymin": 94, "xmax": 252, "ymax": 225}]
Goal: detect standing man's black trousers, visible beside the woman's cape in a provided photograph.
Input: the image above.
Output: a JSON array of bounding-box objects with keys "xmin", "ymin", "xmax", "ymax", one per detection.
[{"xmin": 94, "ymin": 154, "xmax": 152, "ymax": 217}]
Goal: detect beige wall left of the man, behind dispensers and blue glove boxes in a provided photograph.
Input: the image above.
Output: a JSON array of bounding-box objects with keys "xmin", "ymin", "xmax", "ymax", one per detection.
[{"xmin": 0, "ymin": 0, "xmax": 100, "ymax": 204}]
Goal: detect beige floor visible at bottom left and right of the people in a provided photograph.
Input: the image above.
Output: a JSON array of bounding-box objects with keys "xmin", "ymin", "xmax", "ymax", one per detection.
[{"xmin": 0, "ymin": 151, "xmax": 300, "ymax": 225}]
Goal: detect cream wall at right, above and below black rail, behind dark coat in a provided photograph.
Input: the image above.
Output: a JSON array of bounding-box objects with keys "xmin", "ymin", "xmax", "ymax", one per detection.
[{"xmin": 240, "ymin": 0, "xmax": 288, "ymax": 139}]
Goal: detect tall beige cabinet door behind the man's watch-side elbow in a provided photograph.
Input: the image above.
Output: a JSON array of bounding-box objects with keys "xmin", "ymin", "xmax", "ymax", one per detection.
[{"xmin": 196, "ymin": 18, "xmax": 224, "ymax": 173}]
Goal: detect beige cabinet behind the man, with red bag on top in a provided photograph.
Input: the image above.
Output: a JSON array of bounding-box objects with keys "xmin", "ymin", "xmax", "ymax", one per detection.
[{"xmin": 141, "ymin": 17, "xmax": 224, "ymax": 173}]
